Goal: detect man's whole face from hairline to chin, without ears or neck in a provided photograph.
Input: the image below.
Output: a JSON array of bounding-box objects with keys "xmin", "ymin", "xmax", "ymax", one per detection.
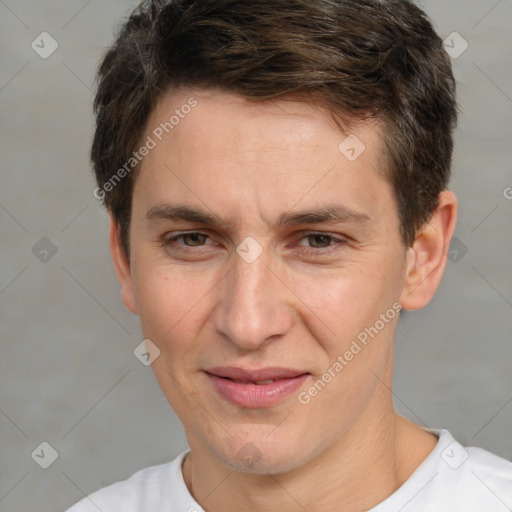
[{"xmin": 125, "ymin": 90, "xmax": 405, "ymax": 472}]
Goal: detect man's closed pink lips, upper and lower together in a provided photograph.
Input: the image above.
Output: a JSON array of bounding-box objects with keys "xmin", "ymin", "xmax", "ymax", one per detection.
[{"xmin": 205, "ymin": 367, "xmax": 310, "ymax": 409}]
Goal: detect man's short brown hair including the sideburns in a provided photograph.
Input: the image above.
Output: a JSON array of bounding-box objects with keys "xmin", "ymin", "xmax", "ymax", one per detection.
[{"xmin": 91, "ymin": 0, "xmax": 457, "ymax": 257}]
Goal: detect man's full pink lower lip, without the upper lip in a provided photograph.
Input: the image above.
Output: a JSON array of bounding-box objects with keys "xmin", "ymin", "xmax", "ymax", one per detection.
[{"xmin": 206, "ymin": 373, "xmax": 309, "ymax": 409}]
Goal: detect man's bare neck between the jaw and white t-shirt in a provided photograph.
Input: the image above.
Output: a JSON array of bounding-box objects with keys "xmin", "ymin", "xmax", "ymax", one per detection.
[{"xmin": 183, "ymin": 386, "xmax": 437, "ymax": 512}]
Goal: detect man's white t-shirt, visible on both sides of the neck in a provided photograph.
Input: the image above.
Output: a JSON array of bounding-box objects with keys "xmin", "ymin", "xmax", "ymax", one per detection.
[{"xmin": 67, "ymin": 430, "xmax": 512, "ymax": 512}]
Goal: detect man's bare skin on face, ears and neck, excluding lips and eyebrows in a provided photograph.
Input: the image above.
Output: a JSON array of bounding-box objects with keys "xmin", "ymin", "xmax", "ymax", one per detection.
[{"xmin": 110, "ymin": 89, "xmax": 457, "ymax": 512}]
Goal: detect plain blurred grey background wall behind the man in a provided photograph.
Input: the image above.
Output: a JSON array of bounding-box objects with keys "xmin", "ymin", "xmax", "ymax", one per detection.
[{"xmin": 0, "ymin": 0, "xmax": 512, "ymax": 512}]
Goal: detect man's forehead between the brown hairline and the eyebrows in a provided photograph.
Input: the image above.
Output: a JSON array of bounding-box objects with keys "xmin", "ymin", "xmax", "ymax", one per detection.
[{"xmin": 135, "ymin": 89, "xmax": 392, "ymax": 232}]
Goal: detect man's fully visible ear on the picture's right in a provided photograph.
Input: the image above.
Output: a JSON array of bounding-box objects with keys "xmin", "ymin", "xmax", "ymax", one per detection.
[{"xmin": 400, "ymin": 190, "xmax": 457, "ymax": 310}]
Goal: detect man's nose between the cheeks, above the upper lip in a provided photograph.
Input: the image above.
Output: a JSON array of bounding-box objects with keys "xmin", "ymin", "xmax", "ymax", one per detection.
[{"xmin": 215, "ymin": 245, "xmax": 292, "ymax": 350}]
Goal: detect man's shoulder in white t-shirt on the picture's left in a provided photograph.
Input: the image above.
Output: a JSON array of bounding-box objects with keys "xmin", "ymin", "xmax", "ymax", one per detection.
[{"xmin": 66, "ymin": 451, "xmax": 187, "ymax": 512}]
